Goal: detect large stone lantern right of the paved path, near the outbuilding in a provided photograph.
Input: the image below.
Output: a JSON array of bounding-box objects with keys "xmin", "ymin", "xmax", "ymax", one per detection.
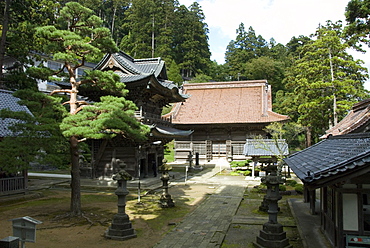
[{"xmin": 254, "ymin": 165, "xmax": 292, "ymax": 248}]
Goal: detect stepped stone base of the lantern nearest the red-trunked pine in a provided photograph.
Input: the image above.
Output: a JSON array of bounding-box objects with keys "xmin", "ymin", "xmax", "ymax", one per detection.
[{"xmin": 105, "ymin": 214, "xmax": 137, "ymax": 240}]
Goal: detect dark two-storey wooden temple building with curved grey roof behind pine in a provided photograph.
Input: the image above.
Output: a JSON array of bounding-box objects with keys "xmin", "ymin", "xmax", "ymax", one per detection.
[{"xmin": 60, "ymin": 52, "xmax": 192, "ymax": 178}]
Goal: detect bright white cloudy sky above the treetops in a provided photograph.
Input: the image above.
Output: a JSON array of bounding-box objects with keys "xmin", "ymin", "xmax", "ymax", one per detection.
[{"xmin": 179, "ymin": 0, "xmax": 370, "ymax": 89}]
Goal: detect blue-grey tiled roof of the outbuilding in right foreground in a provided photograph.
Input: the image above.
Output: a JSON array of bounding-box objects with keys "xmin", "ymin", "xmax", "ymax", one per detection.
[{"xmin": 284, "ymin": 133, "xmax": 370, "ymax": 183}]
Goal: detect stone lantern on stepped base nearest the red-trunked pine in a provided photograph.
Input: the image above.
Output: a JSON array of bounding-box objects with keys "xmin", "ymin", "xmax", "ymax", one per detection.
[{"xmin": 105, "ymin": 163, "xmax": 136, "ymax": 240}]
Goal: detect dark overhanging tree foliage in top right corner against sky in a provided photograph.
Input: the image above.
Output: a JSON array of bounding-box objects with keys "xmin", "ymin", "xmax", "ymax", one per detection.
[{"xmin": 345, "ymin": 0, "xmax": 370, "ymax": 50}]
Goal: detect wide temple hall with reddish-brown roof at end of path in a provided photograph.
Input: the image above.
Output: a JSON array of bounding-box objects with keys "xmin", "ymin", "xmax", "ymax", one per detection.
[{"xmin": 166, "ymin": 80, "xmax": 289, "ymax": 163}]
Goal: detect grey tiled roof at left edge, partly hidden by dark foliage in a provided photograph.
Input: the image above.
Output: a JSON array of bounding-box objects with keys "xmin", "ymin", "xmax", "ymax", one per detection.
[{"xmin": 0, "ymin": 90, "xmax": 32, "ymax": 137}]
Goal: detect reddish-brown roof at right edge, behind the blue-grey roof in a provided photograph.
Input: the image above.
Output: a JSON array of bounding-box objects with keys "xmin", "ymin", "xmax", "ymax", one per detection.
[{"xmin": 321, "ymin": 99, "xmax": 370, "ymax": 138}]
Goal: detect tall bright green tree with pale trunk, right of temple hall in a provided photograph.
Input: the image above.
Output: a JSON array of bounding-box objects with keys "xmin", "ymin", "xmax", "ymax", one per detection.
[{"xmin": 285, "ymin": 22, "xmax": 368, "ymax": 144}]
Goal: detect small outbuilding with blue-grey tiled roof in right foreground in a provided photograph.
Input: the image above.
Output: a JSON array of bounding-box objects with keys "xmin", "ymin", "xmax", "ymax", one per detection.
[{"xmin": 284, "ymin": 133, "xmax": 370, "ymax": 247}]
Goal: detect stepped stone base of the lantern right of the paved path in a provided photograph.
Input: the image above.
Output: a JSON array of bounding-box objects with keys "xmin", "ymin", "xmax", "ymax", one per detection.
[{"xmin": 253, "ymin": 223, "xmax": 293, "ymax": 248}]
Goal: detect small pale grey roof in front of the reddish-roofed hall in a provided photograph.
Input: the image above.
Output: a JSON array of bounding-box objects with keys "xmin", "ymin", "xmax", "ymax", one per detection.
[{"xmin": 243, "ymin": 139, "xmax": 289, "ymax": 156}]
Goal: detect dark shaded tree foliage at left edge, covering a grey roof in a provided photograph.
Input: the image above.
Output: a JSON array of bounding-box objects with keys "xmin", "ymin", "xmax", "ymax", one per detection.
[{"xmin": 0, "ymin": 90, "xmax": 69, "ymax": 173}]
